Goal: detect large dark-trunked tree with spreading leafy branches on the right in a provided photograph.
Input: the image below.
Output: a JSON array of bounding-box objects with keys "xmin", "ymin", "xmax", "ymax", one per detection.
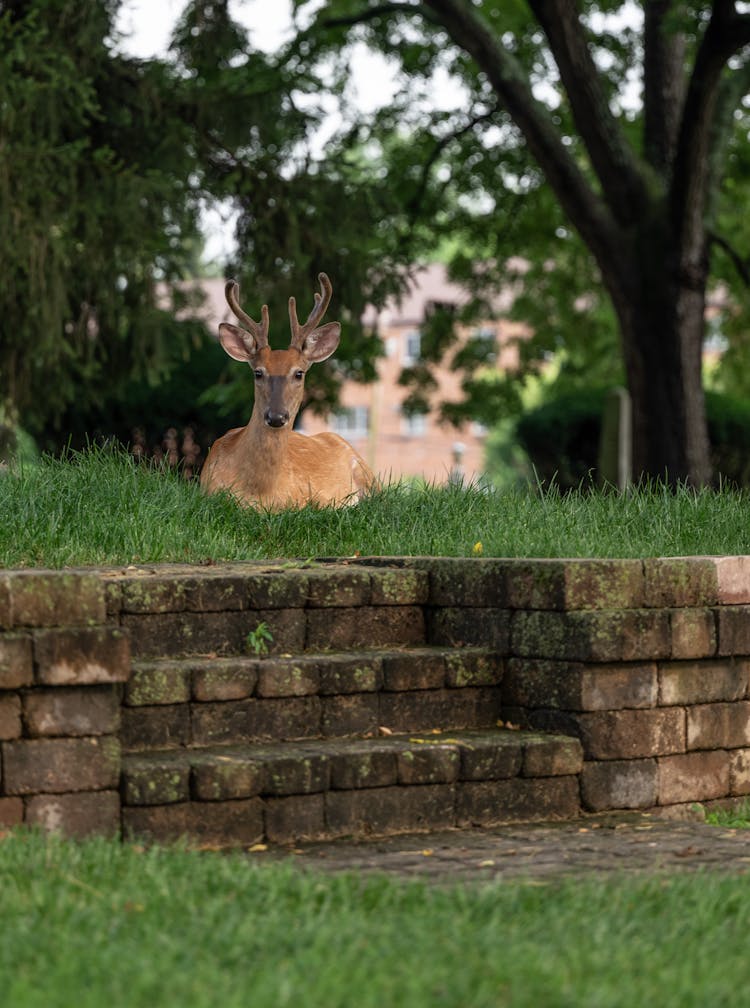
[{"xmin": 296, "ymin": 0, "xmax": 750, "ymax": 485}]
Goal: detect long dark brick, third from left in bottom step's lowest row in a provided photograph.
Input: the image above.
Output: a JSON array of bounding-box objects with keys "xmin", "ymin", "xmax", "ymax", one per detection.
[{"xmin": 325, "ymin": 784, "xmax": 456, "ymax": 837}]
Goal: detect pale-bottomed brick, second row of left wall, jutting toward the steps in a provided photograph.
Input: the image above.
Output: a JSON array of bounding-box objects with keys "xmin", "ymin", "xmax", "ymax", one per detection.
[{"xmin": 34, "ymin": 627, "xmax": 130, "ymax": 685}]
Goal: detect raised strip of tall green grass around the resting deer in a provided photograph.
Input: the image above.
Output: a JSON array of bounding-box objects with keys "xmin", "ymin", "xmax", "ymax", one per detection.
[{"xmin": 0, "ymin": 450, "xmax": 750, "ymax": 568}]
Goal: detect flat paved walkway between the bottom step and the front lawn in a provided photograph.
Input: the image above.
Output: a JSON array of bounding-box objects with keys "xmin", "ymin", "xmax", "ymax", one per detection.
[{"xmin": 255, "ymin": 814, "xmax": 750, "ymax": 883}]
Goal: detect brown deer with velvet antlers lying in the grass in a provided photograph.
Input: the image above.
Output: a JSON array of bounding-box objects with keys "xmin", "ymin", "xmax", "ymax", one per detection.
[{"xmin": 201, "ymin": 273, "xmax": 375, "ymax": 510}]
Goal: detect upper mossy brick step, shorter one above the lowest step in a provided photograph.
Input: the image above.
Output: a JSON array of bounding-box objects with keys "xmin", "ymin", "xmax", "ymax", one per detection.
[{"xmin": 121, "ymin": 647, "xmax": 503, "ymax": 751}]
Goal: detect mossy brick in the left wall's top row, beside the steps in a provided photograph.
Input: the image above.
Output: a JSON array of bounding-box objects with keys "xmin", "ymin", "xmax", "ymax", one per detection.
[{"xmin": 0, "ymin": 571, "xmax": 107, "ymax": 627}]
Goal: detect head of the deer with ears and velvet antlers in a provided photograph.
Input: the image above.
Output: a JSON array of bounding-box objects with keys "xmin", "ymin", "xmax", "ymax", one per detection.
[{"xmin": 219, "ymin": 273, "xmax": 341, "ymax": 428}]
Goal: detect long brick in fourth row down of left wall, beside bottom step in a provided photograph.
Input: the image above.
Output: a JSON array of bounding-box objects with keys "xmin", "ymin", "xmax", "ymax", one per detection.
[{"xmin": 3, "ymin": 736, "xmax": 120, "ymax": 794}]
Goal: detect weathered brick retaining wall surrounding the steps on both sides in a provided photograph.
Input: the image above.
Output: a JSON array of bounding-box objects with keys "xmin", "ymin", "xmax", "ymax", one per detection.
[{"xmin": 0, "ymin": 556, "xmax": 750, "ymax": 835}]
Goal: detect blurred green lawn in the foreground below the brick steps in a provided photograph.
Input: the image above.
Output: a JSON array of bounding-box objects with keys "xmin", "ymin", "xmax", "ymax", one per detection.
[{"xmin": 0, "ymin": 833, "xmax": 750, "ymax": 1008}]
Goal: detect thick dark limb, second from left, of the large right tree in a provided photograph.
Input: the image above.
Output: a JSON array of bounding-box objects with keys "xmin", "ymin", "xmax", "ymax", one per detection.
[{"xmin": 529, "ymin": 0, "xmax": 646, "ymax": 225}]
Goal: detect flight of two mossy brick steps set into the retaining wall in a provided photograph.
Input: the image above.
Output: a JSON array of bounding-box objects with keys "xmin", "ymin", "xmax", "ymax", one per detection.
[{"xmin": 120, "ymin": 628, "xmax": 583, "ymax": 846}]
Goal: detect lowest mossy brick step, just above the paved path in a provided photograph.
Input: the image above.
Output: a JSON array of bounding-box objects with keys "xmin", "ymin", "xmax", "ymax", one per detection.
[{"xmin": 122, "ymin": 729, "xmax": 583, "ymax": 847}]
